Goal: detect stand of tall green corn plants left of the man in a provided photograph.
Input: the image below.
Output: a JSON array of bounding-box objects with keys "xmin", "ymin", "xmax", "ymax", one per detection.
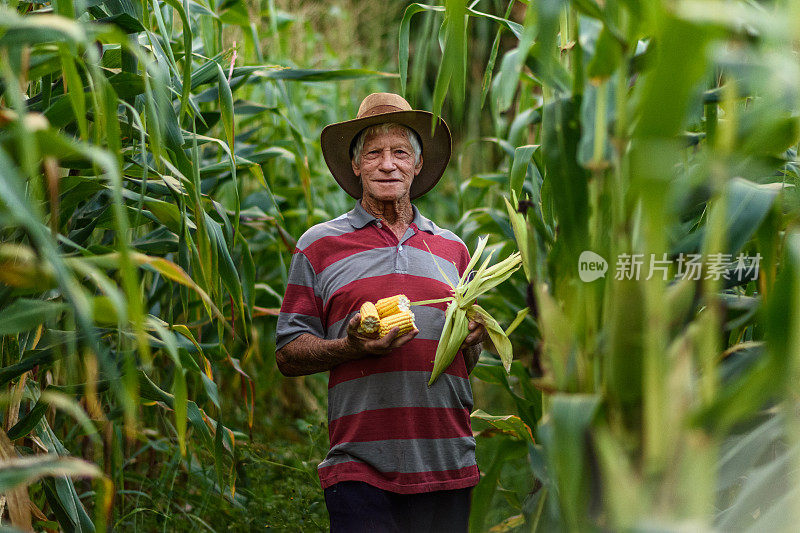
[{"xmin": 0, "ymin": 0, "xmax": 400, "ymax": 531}]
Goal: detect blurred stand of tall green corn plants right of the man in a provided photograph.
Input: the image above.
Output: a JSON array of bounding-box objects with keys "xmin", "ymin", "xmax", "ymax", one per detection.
[{"xmin": 399, "ymin": 0, "xmax": 800, "ymax": 531}]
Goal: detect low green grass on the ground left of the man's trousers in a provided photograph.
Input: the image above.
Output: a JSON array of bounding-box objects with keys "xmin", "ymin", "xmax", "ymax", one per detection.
[{"xmin": 116, "ymin": 404, "xmax": 328, "ymax": 532}]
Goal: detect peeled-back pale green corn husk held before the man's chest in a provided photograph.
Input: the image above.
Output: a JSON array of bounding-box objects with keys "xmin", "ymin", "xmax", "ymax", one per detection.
[{"xmin": 411, "ymin": 237, "xmax": 522, "ymax": 386}]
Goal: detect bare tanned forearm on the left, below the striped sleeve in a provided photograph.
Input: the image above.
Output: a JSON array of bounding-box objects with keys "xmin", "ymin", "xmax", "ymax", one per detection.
[{"xmin": 275, "ymin": 333, "xmax": 363, "ymax": 376}]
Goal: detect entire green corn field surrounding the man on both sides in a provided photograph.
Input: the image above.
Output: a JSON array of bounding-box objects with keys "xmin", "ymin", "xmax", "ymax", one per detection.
[{"xmin": 0, "ymin": 0, "xmax": 800, "ymax": 532}]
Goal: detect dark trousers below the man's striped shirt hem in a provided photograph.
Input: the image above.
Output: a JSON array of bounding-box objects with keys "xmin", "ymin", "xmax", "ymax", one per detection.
[{"xmin": 325, "ymin": 481, "xmax": 472, "ymax": 533}]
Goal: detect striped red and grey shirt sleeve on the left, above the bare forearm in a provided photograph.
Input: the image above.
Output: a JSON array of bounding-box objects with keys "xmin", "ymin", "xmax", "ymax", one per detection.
[{"xmin": 275, "ymin": 250, "xmax": 325, "ymax": 350}]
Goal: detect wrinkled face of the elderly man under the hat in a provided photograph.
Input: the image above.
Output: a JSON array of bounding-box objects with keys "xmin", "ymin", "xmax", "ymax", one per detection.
[{"xmin": 353, "ymin": 130, "xmax": 422, "ymax": 202}]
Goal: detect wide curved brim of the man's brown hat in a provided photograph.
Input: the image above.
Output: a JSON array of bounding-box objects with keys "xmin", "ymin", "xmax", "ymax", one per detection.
[{"xmin": 320, "ymin": 110, "xmax": 452, "ymax": 200}]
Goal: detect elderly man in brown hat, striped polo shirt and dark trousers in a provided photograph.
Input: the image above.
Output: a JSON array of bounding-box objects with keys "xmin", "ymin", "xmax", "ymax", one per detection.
[{"xmin": 276, "ymin": 93, "xmax": 486, "ymax": 532}]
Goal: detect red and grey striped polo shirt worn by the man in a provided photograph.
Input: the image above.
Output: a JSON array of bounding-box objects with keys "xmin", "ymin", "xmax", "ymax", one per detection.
[{"xmin": 276, "ymin": 202, "xmax": 478, "ymax": 494}]
